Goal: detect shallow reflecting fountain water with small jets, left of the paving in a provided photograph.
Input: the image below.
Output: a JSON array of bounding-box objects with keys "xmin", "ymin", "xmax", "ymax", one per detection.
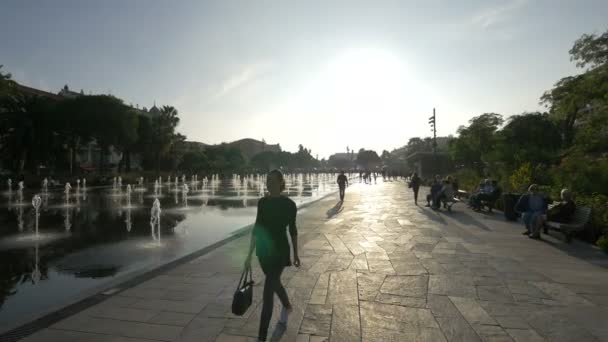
[{"xmin": 0, "ymin": 175, "xmax": 352, "ymax": 331}]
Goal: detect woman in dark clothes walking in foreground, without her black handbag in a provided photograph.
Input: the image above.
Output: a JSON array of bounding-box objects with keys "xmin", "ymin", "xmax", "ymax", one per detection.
[{"xmin": 245, "ymin": 170, "xmax": 300, "ymax": 341}]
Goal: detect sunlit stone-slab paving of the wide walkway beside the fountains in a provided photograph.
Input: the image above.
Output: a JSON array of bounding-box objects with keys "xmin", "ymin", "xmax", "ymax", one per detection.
[{"xmin": 23, "ymin": 182, "xmax": 608, "ymax": 342}]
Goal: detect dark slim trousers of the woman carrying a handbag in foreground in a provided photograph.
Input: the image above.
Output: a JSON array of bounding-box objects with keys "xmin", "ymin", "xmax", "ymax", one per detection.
[{"xmin": 258, "ymin": 260, "xmax": 290, "ymax": 341}]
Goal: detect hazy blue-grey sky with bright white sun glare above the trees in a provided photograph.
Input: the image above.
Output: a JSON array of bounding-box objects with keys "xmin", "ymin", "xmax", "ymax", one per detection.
[{"xmin": 0, "ymin": 0, "xmax": 608, "ymax": 158}]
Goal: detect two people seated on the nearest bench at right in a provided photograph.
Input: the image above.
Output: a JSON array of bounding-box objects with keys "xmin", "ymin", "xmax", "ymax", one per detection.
[{"xmin": 515, "ymin": 184, "xmax": 576, "ymax": 239}]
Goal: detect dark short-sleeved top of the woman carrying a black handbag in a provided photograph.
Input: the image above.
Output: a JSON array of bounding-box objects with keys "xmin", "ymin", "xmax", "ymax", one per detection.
[{"xmin": 254, "ymin": 196, "xmax": 298, "ymax": 266}]
